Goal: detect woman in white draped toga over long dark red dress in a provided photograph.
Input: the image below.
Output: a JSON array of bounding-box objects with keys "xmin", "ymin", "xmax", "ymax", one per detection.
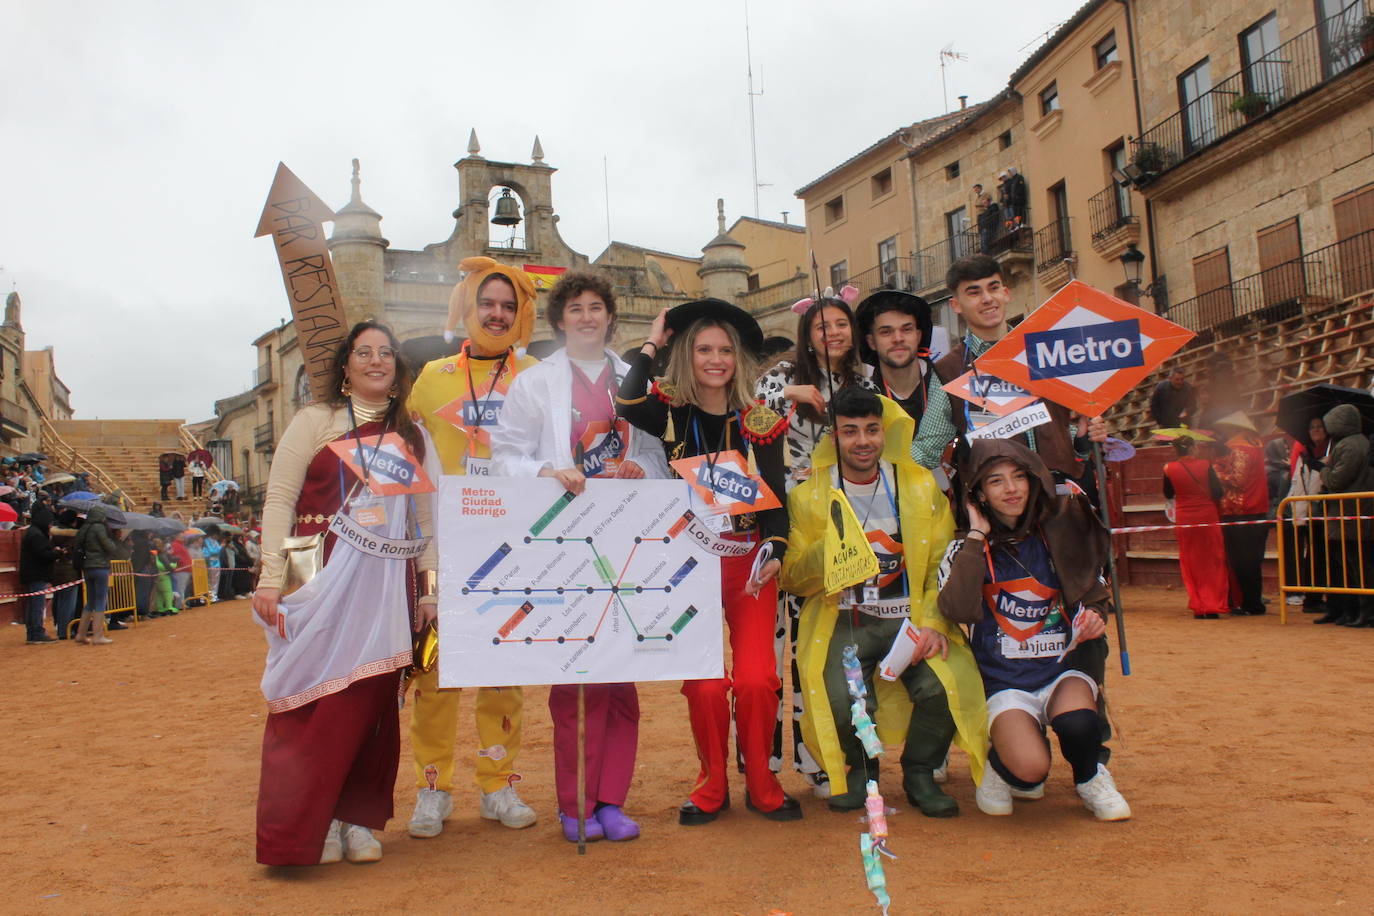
[{"xmin": 253, "ymin": 321, "xmax": 438, "ymax": 865}]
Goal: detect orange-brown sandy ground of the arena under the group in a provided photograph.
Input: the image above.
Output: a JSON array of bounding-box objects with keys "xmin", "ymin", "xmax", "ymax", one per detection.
[{"xmin": 0, "ymin": 589, "xmax": 1374, "ymax": 916}]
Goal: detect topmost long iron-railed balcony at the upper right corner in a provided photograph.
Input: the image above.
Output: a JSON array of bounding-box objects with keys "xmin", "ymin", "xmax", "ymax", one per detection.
[{"xmin": 1128, "ymin": 0, "xmax": 1370, "ymax": 187}]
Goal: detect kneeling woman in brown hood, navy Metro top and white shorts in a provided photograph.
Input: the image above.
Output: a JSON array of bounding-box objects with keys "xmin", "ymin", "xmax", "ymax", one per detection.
[{"xmin": 940, "ymin": 439, "xmax": 1131, "ymax": 821}]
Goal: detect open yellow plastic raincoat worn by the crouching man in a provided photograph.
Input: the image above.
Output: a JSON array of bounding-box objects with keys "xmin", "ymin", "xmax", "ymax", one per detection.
[{"xmin": 779, "ymin": 398, "xmax": 988, "ymax": 795}]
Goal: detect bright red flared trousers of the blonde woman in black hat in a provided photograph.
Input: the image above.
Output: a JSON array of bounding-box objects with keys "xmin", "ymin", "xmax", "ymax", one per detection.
[{"xmin": 683, "ymin": 543, "xmax": 783, "ymax": 812}]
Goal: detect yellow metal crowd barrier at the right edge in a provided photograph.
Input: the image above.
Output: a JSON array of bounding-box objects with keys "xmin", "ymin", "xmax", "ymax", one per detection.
[{"xmin": 1275, "ymin": 493, "xmax": 1374, "ymax": 623}]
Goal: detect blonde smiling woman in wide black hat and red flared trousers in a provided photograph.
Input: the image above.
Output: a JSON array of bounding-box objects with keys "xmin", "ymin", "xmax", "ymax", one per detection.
[{"xmin": 616, "ymin": 299, "xmax": 801, "ymax": 825}]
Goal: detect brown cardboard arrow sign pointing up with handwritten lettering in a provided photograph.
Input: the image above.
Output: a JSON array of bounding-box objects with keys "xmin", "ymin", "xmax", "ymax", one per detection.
[{"xmin": 254, "ymin": 162, "xmax": 348, "ymax": 401}]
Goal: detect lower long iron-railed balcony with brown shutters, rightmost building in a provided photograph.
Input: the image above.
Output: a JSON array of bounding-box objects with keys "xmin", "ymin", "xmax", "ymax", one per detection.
[{"xmin": 1167, "ymin": 229, "xmax": 1374, "ymax": 342}]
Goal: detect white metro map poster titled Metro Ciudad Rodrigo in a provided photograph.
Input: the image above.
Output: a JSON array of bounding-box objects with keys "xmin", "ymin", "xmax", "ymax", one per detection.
[{"xmin": 436, "ymin": 477, "xmax": 724, "ymax": 687}]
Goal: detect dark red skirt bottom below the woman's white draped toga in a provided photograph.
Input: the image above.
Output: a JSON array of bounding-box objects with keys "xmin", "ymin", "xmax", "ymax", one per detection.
[{"xmin": 257, "ymin": 670, "xmax": 401, "ymax": 865}]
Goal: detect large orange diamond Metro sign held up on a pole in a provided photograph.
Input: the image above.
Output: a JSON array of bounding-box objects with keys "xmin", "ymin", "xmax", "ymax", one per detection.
[{"xmin": 977, "ymin": 280, "xmax": 1194, "ymax": 416}]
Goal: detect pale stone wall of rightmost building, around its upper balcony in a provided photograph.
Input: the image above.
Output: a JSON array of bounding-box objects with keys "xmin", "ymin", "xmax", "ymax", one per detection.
[{"xmin": 1136, "ymin": 0, "xmax": 1374, "ymax": 310}]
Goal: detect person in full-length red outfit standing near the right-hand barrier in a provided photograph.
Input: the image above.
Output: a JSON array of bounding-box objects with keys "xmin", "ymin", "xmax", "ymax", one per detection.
[{"xmin": 1164, "ymin": 438, "xmax": 1230, "ymax": 621}]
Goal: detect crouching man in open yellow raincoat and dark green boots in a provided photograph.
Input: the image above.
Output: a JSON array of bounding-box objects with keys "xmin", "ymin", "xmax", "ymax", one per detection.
[{"xmin": 780, "ymin": 387, "xmax": 988, "ymax": 817}]
